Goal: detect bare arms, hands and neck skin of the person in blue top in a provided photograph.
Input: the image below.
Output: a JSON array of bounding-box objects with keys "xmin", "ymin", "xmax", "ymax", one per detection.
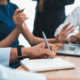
[{"xmin": 0, "ymin": 0, "xmax": 73, "ymax": 47}]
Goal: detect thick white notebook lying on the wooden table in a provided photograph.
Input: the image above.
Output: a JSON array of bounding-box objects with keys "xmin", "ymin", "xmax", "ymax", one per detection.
[{"xmin": 20, "ymin": 58, "xmax": 75, "ymax": 72}]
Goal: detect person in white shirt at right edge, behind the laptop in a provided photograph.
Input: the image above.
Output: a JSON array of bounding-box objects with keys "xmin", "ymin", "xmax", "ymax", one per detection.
[{"xmin": 54, "ymin": 7, "xmax": 80, "ymax": 43}]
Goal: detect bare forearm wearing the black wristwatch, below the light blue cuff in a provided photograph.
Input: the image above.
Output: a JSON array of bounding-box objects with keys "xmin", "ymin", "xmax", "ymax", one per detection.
[{"xmin": 10, "ymin": 48, "xmax": 30, "ymax": 63}]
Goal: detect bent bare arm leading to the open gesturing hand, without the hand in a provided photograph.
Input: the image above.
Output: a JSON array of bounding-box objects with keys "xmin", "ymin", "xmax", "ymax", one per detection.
[{"xmin": 23, "ymin": 23, "xmax": 56, "ymax": 46}]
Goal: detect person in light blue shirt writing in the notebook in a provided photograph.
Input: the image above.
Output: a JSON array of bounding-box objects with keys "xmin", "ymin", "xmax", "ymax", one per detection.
[{"xmin": 0, "ymin": 43, "xmax": 57, "ymax": 80}]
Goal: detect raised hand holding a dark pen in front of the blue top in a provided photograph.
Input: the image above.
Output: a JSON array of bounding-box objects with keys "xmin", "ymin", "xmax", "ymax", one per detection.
[{"xmin": 13, "ymin": 9, "xmax": 28, "ymax": 32}]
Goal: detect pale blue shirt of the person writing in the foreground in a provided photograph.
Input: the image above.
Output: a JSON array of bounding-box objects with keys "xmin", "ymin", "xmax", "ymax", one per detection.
[{"xmin": 0, "ymin": 48, "xmax": 47, "ymax": 80}]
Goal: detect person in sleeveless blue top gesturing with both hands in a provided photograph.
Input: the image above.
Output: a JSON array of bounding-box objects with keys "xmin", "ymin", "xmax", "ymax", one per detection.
[{"xmin": 0, "ymin": 0, "xmax": 73, "ymax": 68}]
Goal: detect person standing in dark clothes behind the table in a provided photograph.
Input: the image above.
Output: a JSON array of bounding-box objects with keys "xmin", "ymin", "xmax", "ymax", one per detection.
[{"xmin": 32, "ymin": 0, "xmax": 74, "ymax": 38}]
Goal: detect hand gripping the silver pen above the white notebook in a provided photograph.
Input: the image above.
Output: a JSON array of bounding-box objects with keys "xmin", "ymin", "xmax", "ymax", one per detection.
[{"xmin": 28, "ymin": 43, "xmax": 57, "ymax": 59}]
